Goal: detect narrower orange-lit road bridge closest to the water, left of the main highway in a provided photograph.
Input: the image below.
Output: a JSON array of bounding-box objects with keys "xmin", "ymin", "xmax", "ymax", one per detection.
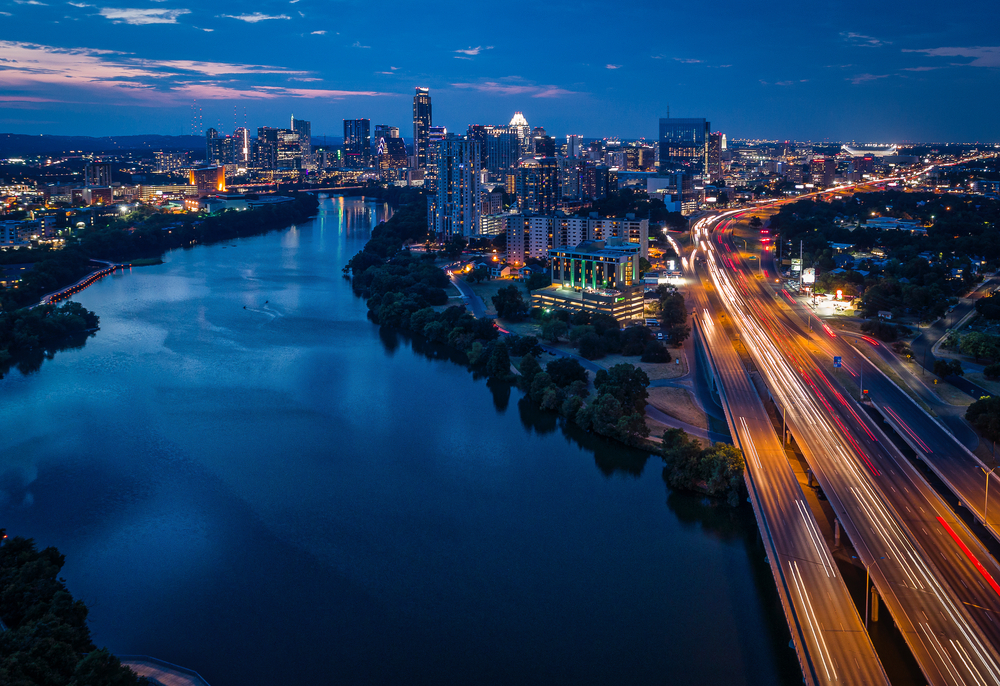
[{"xmin": 689, "ymin": 246, "xmax": 888, "ymax": 684}]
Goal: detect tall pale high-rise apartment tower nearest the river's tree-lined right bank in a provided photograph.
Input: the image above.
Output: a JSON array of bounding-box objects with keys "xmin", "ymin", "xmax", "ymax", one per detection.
[{"xmin": 431, "ymin": 134, "xmax": 482, "ymax": 239}]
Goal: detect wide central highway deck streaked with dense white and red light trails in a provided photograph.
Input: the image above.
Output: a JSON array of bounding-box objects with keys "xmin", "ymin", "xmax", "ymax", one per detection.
[{"xmin": 696, "ymin": 212, "xmax": 1000, "ymax": 684}]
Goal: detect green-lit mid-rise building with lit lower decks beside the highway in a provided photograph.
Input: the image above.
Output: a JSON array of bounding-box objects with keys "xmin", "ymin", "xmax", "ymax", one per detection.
[{"xmin": 531, "ymin": 239, "xmax": 643, "ymax": 322}]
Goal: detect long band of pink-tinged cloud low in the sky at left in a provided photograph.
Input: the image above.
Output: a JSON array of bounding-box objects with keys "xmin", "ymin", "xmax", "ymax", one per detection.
[{"xmin": 0, "ymin": 41, "xmax": 394, "ymax": 107}]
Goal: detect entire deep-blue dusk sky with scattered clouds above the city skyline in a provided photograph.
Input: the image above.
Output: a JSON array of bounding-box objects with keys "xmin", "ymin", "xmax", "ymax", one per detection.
[{"xmin": 0, "ymin": 0, "xmax": 1000, "ymax": 142}]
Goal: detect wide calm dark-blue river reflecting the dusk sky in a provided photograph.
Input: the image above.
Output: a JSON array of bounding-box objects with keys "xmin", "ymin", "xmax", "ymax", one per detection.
[{"xmin": 0, "ymin": 198, "xmax": 801, "ymax": 686}]
